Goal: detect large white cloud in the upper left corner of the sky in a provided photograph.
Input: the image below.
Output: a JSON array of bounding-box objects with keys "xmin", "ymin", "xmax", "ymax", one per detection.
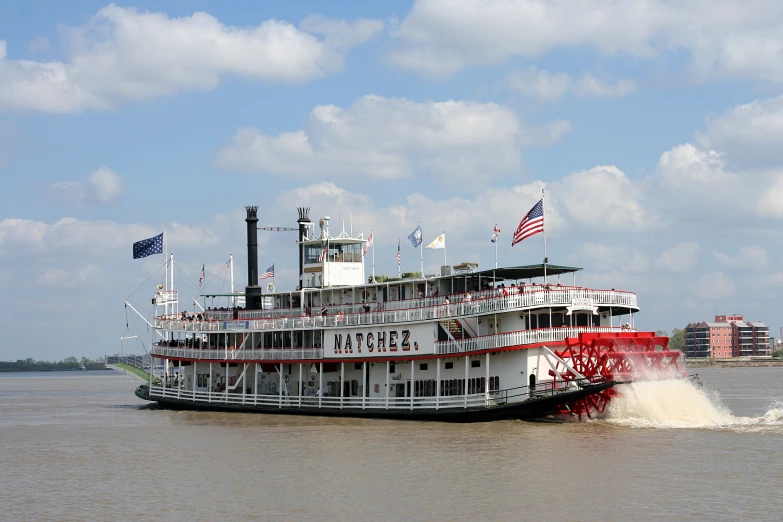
[{"xmin": 0, "ymin": 4, "xmax": 384, "ymax": 112}]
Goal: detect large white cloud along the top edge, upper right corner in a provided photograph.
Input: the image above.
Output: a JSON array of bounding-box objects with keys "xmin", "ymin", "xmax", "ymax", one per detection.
[{"xmin": 388, "ymin": 0, "xmax": 783, "ymax": 82}]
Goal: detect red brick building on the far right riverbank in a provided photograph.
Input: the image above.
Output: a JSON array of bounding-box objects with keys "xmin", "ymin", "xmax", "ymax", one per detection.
[{"xmin": 685, "ymin": 315, "xmax": 772, "ymax": 359}]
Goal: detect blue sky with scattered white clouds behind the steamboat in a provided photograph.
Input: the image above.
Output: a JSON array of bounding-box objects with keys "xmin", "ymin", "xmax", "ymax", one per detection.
[{"xmin": 0, "ymin": 0, "xmax": 783, "ymax": 359}]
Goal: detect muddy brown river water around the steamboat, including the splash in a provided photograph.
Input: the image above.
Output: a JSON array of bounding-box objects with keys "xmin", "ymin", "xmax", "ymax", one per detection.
[{"xmin": 0, "ymin": 368, "xmax": 783, "ymax": 521}]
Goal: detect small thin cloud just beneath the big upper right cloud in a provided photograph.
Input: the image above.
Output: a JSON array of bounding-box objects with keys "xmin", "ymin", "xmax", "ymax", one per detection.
[{"xmin": 506, "ymin": 67, "xmax": 636, "ymax": 102}]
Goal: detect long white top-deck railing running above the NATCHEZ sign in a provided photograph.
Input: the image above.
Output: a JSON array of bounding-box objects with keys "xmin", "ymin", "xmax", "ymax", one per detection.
[{"xmin": 155, "ymin": 288, "xmax": 637, "ymax": 332}]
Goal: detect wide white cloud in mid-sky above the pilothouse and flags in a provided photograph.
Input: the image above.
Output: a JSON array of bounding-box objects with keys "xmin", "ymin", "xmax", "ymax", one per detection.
[{"xmin": 215, "ymin": 95, "xmax": 570, "ymax": 182}]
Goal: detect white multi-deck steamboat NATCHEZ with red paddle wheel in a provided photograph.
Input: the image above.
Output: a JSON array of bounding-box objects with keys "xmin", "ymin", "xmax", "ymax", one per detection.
[{"xmin": 126, "ymin": 206, "xmax": 682, "ymax": 422}]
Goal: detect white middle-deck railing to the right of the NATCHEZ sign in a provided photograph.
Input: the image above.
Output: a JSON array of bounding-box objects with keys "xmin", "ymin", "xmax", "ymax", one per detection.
[{"xmin": 435, "ymin": 326, "xmax": 635, "ymax": 355}]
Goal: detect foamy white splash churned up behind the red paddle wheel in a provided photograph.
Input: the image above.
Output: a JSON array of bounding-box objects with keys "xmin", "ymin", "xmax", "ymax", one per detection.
[{"xmin": 604, "ymin": 379, "xmax": 783, "ymax": 431}]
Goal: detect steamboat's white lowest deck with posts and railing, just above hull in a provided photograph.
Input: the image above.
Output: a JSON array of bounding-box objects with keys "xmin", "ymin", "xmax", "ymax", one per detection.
[{"xmin": 145, "ymin": 347, "xmax": 608, "ymax": 413}]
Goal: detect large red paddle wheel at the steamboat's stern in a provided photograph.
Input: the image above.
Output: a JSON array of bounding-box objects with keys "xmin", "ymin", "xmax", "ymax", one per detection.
[{"xmin": 549, "ymin": 332, "xmax": 687, "ymax": 420}]
